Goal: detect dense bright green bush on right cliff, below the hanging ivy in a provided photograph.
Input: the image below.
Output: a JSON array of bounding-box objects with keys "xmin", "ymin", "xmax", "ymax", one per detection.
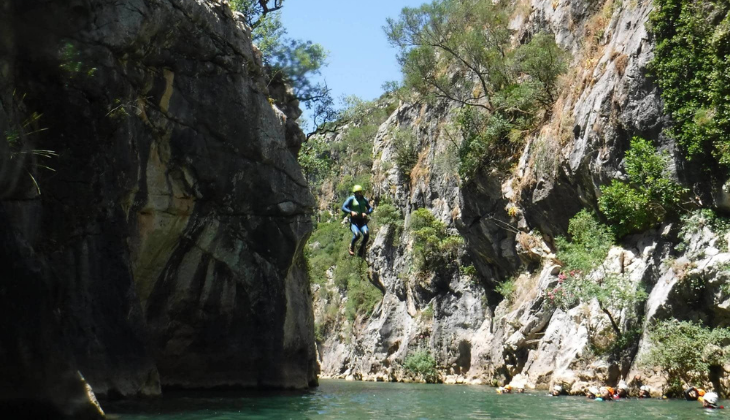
[{"xmin": 598, "ymin": 137, "xmax": 687, "ymax": 238}]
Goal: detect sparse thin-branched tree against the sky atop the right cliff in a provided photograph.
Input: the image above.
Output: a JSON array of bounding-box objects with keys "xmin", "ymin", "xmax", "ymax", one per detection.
[{"xmin": 383, "ymin": 0, "xmax": 511, "ymax": 111}]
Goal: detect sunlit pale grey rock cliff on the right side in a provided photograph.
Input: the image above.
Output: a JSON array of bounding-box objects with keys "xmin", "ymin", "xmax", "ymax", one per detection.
[{"xmin": 313, "ymin": 0, "xmax": 730, "ymax": 393}]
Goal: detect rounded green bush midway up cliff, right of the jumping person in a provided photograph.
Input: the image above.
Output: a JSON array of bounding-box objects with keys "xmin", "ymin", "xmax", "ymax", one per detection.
[{"xmin": 409, "ymin": 209, "xmax": 464, "ymax": 272}]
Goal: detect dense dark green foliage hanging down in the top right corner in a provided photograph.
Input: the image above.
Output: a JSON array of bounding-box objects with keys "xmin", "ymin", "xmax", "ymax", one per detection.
[{"xmin": 648, "ymin": 0, "xmax": 730, "ymax": 168}]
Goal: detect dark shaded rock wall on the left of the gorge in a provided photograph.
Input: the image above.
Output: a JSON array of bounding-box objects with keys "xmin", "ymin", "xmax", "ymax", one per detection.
[{"xmin": 0, "ymin": 0, "xmax": 317, "ymax": 410}]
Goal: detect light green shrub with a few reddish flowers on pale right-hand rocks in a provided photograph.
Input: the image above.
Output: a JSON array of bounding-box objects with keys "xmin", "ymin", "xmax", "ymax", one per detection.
[{"xmin": 547, "ymin": 210, "xmax": 646, "ymax": 339}]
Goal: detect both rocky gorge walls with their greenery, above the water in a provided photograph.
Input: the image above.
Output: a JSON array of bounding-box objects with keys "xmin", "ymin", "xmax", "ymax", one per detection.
[{"xmin": 0, "ymin": 0, "xmax": 730, "ymax": 419}]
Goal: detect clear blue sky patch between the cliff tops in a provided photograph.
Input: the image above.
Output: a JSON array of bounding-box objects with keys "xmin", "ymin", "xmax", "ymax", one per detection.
[{"xmin": 281, "ymin": 0, "xmax": 426, "ymax": 106}]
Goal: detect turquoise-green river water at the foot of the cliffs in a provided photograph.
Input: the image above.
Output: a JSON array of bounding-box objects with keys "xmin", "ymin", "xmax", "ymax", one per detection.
[{"xmin": 103, "ymin": 380, "xmax": 730, "ymax": 420}]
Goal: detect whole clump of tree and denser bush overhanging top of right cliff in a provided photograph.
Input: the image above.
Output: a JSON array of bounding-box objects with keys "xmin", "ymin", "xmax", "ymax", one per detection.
[{"xmin": 384, "ymin": 0, "xmax": 568, "ymax": 181}]
